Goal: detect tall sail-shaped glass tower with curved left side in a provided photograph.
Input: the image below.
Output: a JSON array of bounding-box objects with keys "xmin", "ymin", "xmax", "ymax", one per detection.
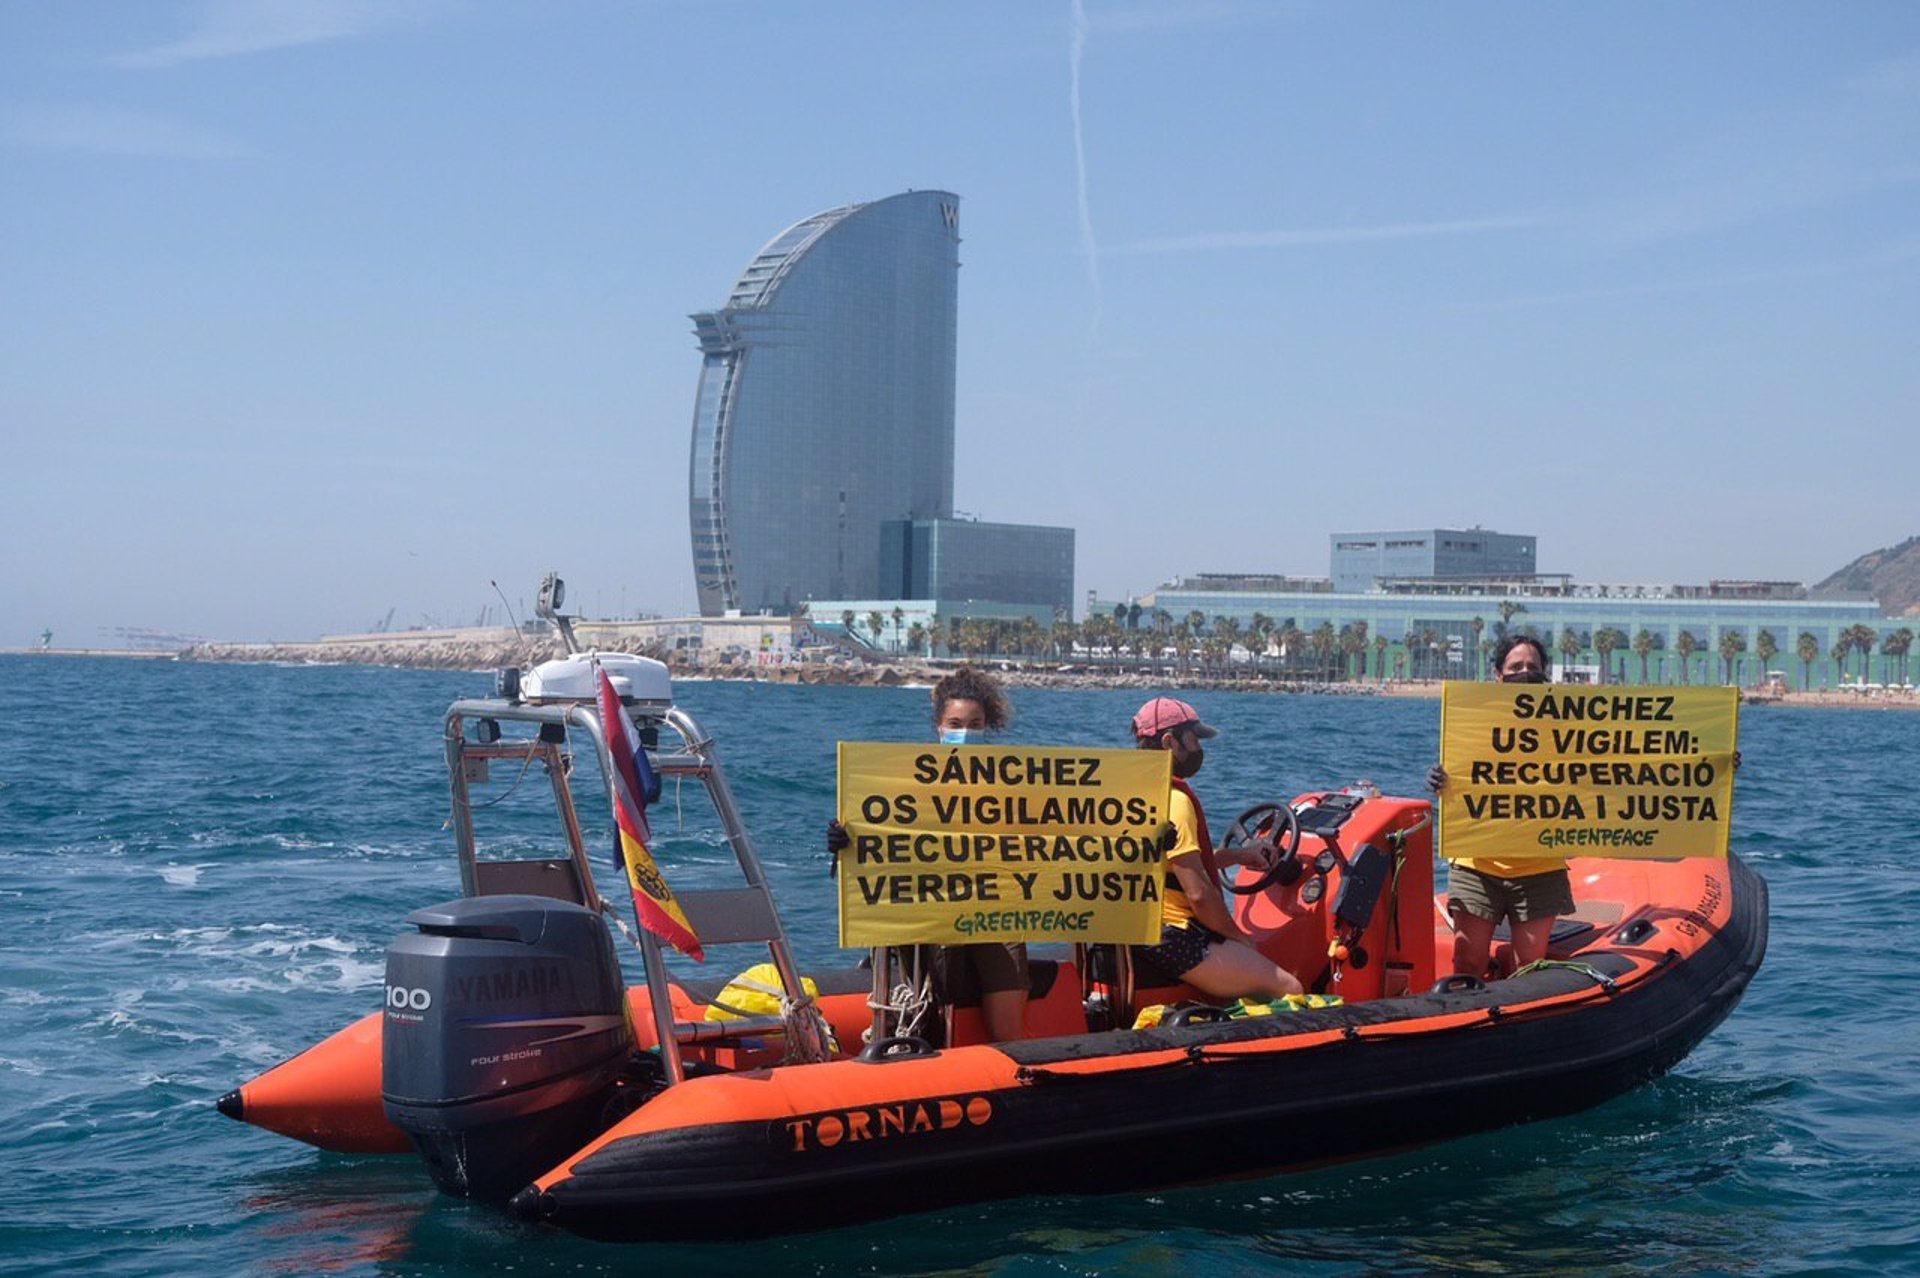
[{"xmin": 689, "ymin": 190, "xmax": 960, "ymax": 616}]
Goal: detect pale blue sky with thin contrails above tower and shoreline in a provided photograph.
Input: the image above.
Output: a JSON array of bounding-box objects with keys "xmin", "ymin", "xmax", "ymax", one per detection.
[{"xmin": 0, "ymin": 0, "xmax": 1920, "ymax": 647}]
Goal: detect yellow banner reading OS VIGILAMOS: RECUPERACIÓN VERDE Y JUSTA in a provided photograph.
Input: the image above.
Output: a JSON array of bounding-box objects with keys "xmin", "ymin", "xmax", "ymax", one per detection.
[{"xmin": 839, "ymin": 741, "xmax": 1171, "ymax": 946}]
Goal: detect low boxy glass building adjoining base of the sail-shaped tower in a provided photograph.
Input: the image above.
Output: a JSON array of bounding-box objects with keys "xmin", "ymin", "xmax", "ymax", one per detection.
[{"xmin": 879, "ymin": 520, "xmax": 1073, "ymax": 618}]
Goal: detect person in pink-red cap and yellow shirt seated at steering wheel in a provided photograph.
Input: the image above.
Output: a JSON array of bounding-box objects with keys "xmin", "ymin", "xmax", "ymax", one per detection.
[{"xmin": 1133, "ymin": 697, "xmax": 1300, "ymax": 1000}]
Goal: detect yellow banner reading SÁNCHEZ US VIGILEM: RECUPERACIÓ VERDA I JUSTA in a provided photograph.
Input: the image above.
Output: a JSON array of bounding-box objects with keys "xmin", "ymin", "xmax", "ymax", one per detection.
[{"xmin": 1440, "ymin": 683, "xmax": 1740, "ymax": 862}]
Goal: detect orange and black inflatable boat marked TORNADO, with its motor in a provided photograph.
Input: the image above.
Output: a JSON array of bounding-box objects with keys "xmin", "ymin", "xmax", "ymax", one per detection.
[{"xmin": 219, "ymin": 658, "xmax": 1766, "ymax": 1240}]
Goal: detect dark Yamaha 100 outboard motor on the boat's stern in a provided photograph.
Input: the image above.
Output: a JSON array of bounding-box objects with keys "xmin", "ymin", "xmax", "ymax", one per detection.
[{"xmin": 380, "ymin": 896, "xmax": 634, "ymax": 1199}]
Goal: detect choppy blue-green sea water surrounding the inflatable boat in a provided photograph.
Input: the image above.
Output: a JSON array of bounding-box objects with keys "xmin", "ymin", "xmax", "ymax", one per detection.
[{"xmin": 0, "ymin": 658, "xmax": 1920, "ymax": 1274}]
